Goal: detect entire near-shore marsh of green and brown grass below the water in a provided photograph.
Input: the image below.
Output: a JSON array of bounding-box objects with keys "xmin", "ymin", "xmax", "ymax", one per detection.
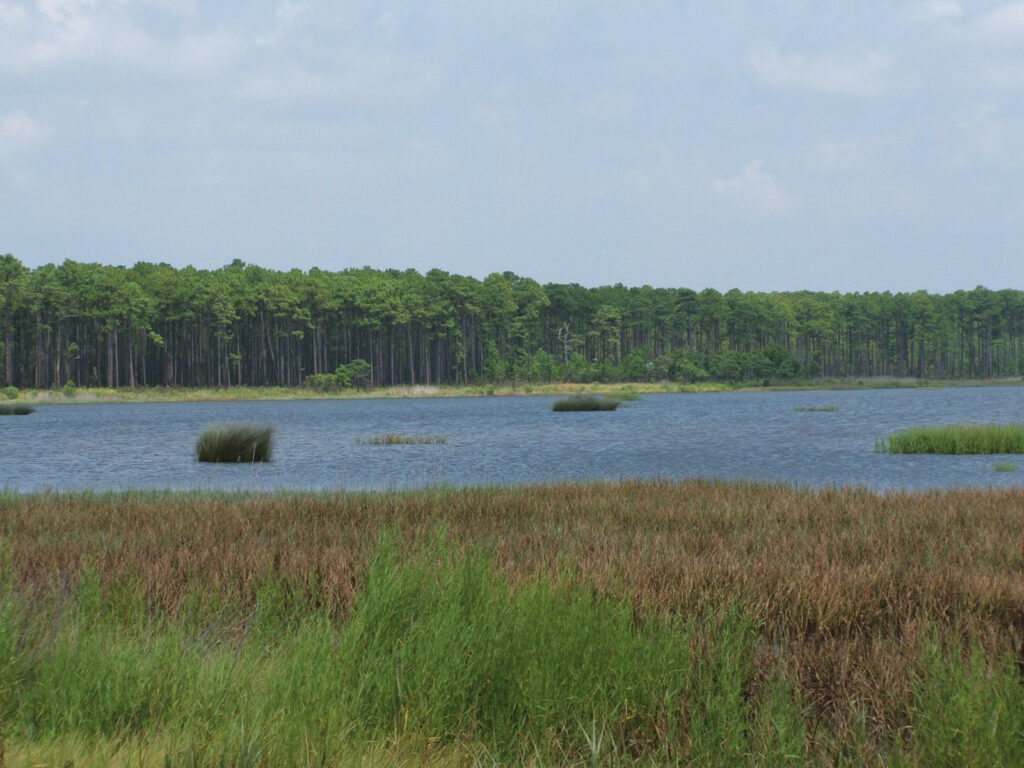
[{"xmin": 0, "ymin": 480, "xmax": 1024, "ymax": 766}]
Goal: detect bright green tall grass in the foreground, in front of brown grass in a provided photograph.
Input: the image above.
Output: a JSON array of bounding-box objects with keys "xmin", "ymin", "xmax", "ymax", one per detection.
[{"xmin": 0, "ymin": 531, "xmax": 1024, "ymax": 768}]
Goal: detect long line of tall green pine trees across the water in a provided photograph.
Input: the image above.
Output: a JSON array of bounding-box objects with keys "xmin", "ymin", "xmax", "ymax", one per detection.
[{"xmin": 0, "ymin": 254, "xmax": 1024, "ymax": 389}]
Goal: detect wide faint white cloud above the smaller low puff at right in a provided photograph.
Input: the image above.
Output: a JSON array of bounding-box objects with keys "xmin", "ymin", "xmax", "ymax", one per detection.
[{"xmin": 750, "ymin": 48, "xmax": 892, "ymax": 96}]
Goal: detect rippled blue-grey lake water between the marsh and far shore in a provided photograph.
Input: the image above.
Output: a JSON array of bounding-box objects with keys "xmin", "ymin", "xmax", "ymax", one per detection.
[{"xmin": 6, "ymin": 387, "xmax": 1024, "ymax": 492}]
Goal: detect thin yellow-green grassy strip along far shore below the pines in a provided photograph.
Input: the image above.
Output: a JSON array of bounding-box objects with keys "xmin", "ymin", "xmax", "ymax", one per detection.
[{"xmin": 8, "ymin": 377, "xmax": 1024, "ymax": 403}]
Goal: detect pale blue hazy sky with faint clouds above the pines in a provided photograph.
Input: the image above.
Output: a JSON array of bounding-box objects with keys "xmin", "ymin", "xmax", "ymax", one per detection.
[{"xmin": 0, "ymin": 0, "xmax": 1024, "ymax": 293}]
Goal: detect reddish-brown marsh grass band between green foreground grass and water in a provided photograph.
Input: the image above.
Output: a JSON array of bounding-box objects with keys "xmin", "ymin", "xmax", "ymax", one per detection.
[{"xmin": 0, "ymin": 480, "xmax": 1024, "ymax": 735}]
